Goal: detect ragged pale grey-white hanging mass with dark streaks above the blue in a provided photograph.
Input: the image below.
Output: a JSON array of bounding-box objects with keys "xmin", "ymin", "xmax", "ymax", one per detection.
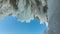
[{"xmin": 0, "ymin": 0, "xmax": 48, "ymax": 25}]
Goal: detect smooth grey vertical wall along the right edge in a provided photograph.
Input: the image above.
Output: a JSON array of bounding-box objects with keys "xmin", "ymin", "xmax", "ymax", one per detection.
[{"xmin": 48, "ymin": 0, "xmax": 60, "ymax": 34}]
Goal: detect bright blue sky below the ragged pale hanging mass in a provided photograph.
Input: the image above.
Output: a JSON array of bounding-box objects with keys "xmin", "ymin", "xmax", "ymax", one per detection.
[{"xmin": 0, "ymin": 16, "xmax": 46, "ymax": 34}]
